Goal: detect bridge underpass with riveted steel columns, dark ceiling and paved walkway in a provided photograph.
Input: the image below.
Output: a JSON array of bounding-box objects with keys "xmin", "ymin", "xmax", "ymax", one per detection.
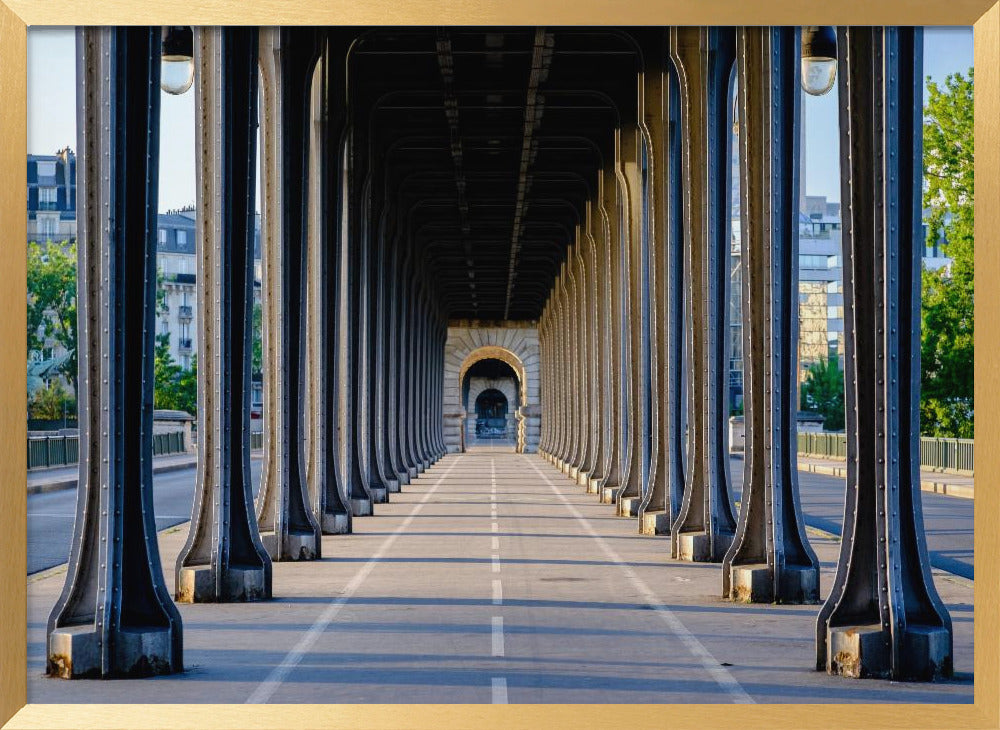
[{"xmin": 37, "ymin": 22, "xmax": 973, "ymax": 702}]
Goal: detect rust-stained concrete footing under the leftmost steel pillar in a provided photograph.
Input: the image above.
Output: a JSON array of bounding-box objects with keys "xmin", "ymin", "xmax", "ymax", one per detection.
[{"xmin": 47, "ymin": 624, "xmax": 180, "ymax": 679}]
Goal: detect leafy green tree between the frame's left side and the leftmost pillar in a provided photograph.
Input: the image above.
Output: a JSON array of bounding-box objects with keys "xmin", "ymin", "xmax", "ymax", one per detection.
[{"xmin": 27, "ymin": 241, "xmax": 77, "ymax": 396}]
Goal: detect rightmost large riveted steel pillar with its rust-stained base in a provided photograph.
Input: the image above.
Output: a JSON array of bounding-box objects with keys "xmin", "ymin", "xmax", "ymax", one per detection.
[{"xmin": 816, "ymin": 27, "xmax": 952, "ymax": 680}]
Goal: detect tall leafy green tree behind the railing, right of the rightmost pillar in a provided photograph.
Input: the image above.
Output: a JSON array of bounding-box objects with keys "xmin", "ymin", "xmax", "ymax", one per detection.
[{"xmin": 920, "ymin": 68, "xmax": 975, "ymax": 438}]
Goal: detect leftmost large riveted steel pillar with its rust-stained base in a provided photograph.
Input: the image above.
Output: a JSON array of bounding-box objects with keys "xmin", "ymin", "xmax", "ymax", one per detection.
[{"xmin": 46, "ymin": 27, "xmax": 183, "ymax": 679}]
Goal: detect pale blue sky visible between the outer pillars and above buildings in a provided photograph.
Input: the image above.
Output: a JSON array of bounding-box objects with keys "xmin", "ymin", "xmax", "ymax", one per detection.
[{"xmin": 28, "ymin": 27, "xmax": 972, "ymax": 210}]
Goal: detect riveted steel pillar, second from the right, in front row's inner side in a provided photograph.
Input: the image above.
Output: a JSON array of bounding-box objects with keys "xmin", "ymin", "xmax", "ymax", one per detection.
[{"xmin": 722, "ymin": 27, "xmax": 819, "ymax": 603}]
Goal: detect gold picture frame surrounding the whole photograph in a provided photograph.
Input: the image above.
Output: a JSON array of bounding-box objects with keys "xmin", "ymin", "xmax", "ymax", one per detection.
[{"xmin": 0, "ymin": 0, "xmax": 1000, "ymax": 730}]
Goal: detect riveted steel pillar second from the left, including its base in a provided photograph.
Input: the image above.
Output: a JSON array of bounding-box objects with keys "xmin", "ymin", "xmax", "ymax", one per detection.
[{"xmin": 176, "ymin": 27, "xmax": 271, "ymax": 603}]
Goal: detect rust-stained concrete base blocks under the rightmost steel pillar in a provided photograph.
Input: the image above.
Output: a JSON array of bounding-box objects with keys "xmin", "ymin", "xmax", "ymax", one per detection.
[{"xmin": 826, "ymin": 624, "xmax": 953, "ymax": 682}]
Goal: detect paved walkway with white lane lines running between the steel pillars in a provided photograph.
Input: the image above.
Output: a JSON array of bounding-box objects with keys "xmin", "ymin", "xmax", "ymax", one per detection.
[{"xmin": 28, "ymin": 452, "xmax": 973, "ymax": 703}]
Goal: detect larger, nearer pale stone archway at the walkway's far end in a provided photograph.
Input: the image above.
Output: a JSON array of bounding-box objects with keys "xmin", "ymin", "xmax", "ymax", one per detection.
[{"xmin": 444, "ymin": 323, "xmax": 541, "ymax": 453}]
